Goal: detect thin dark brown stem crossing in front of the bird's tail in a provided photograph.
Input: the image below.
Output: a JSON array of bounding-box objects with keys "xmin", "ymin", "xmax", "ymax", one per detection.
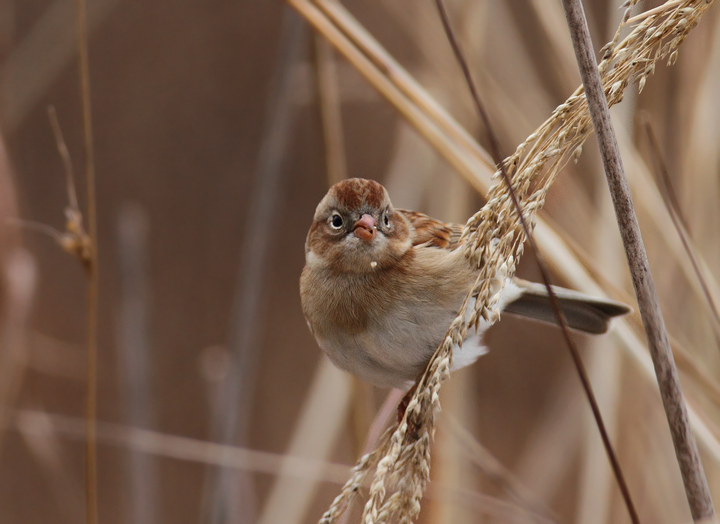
[{"xmin": 436, "ymin": 0, "xmax": 640, "ymax": 524}]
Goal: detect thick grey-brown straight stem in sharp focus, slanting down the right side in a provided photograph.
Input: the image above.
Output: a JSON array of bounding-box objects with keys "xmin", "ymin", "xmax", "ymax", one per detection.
[{"xmin": 563, "ymin": 0, "xmax": 715, "ymax": 522}]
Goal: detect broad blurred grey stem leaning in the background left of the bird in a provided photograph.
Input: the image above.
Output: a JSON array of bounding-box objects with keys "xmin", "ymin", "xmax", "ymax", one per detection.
[{"xmin": 201, "ymin": 8, "xmax": 308, "ymax": 524}]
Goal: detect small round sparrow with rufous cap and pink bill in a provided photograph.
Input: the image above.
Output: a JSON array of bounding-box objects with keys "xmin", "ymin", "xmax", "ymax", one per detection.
[{"xmin": 300, "ymin": 178, "xmax": 631, "ymax": 390}]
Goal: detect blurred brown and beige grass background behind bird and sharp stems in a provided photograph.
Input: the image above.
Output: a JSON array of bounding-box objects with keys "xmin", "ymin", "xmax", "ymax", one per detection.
[{"xmin": 0, "ymin": 0, "xmax": 720, "ymax": 524}]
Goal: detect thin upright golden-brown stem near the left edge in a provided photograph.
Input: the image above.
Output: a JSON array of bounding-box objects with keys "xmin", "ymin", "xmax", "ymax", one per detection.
[{"xmin": 77, "ymin": 0, "xmax": 99, "ymax": 524}]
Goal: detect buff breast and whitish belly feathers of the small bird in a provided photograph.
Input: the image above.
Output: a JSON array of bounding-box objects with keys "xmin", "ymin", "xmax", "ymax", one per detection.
[{"xmin": 302, "ymin": 247, "xmax": 496, "ymax": 388}]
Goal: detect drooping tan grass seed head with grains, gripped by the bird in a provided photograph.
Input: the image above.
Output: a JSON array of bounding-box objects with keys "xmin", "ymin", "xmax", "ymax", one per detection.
[{"xmin": 308, "ymin": 0, "xmax": 710, "ymax": 524}]
